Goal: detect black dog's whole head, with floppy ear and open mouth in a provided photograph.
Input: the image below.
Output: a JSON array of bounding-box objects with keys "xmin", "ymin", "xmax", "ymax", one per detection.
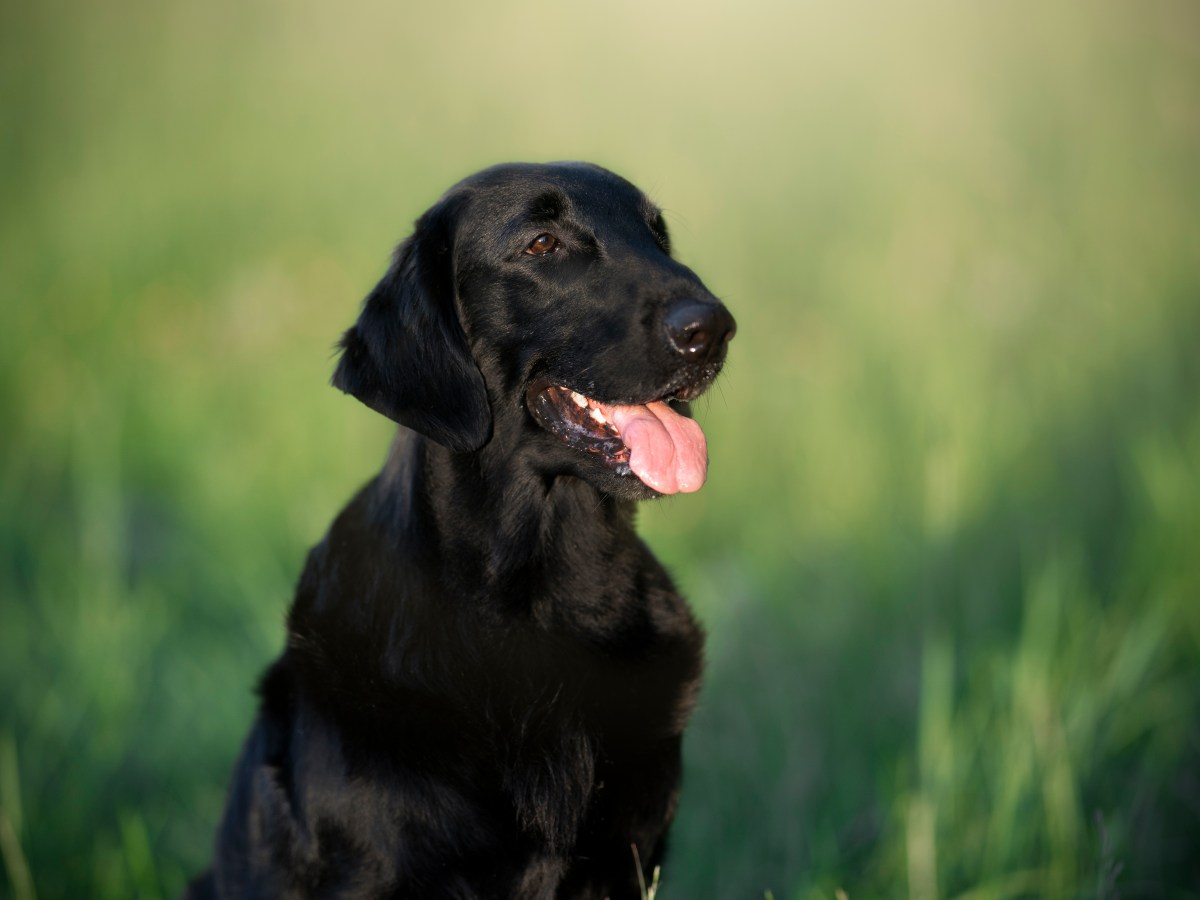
[{"xmin": 334, "ymin": 163, "xmax": 734, "ymax": 498}]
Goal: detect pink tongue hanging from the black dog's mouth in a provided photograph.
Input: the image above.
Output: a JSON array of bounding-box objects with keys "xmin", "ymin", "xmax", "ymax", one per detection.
[{"xmin": 608, "ymin": 401, "xmax": 708, "ymax": 493}]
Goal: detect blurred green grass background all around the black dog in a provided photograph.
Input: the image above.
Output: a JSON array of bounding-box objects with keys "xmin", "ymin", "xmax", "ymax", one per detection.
[{"xmin": 0, "ymin": 0, "xmax": 1200, "ymax": 900}]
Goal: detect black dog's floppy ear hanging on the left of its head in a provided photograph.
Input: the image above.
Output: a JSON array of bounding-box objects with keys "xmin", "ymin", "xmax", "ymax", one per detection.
[{"xmin": 334, "ymin": 200, "xmax": 492, "ymax": 451}]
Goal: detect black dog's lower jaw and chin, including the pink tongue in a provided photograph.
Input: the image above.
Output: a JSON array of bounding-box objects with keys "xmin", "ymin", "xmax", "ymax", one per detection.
[{"xmin": 526, "ymin": 379, "xmax": 710, "ymax": 500}]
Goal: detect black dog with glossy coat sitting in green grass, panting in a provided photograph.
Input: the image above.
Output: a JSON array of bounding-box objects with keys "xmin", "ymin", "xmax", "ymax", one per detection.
[{"xmin": 188, "ymin": 163, "xmax": 734, "ymax": 900}]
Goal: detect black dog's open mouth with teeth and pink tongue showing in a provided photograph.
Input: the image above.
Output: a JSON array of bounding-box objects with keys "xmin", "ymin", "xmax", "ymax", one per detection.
[{"xmin": 526, "ymin": 382, "xmax": 708, "ymax": 493}]
